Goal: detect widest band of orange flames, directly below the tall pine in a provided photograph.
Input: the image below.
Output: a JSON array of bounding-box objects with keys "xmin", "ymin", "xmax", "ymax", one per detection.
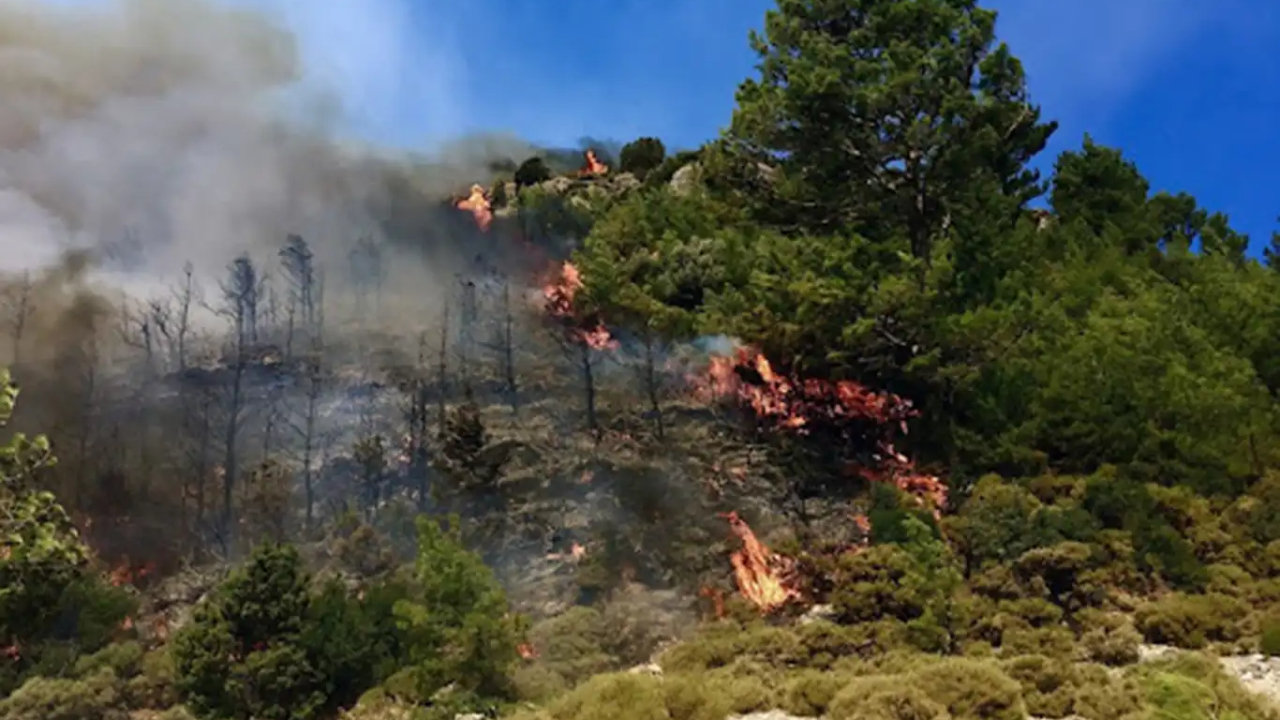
[{"xmin": 694, "ymin": 348, "xmax": 947, "ymax": 516}]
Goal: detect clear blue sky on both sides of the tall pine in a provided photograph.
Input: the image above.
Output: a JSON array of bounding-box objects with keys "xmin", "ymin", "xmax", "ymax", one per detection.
[{"xmin": 35, "ymin": 0, "xmax": 1280, "ymax": 254}]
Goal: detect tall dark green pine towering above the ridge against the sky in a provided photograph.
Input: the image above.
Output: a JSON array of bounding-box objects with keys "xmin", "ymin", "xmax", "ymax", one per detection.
[{"xmin": 724, "ymin": 0, "xmax": 1056, "ymax": 259}]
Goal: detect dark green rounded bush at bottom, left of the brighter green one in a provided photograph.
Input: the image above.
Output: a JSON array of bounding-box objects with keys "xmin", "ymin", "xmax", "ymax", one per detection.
[{"xmin": 172, "ymin": 543, "xmax": 402, "ymax": 720}]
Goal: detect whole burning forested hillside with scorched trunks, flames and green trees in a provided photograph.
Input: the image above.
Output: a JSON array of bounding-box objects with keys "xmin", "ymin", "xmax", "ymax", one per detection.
[{"xmin": 0, "ymin": 0, "xmax": 1280, "ymax": 720}]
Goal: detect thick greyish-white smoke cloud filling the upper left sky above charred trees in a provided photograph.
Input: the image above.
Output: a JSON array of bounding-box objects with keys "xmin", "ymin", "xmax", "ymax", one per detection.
[{"xmin": 0, "ymin": 0, "xmax": 514, "ymax": 294}]
